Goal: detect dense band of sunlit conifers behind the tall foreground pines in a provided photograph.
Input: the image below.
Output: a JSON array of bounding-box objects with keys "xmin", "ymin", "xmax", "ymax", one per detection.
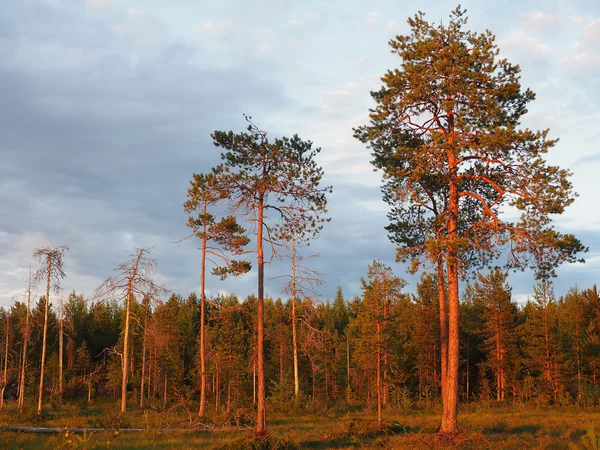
[{"xmin": 0, "ymin": 270, "xmax": 600, "ymax": 415}]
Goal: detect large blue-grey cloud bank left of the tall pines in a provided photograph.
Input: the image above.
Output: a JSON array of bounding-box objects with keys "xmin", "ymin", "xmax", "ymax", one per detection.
[{"xmin": 0, "ymin": 1, "xmax": 291, "ymax": 303}]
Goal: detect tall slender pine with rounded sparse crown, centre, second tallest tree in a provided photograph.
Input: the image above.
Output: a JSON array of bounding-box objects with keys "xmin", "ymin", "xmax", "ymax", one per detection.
[{"xmin": 212, "ymin": 118, "xmax": 331, "ymax": 435}]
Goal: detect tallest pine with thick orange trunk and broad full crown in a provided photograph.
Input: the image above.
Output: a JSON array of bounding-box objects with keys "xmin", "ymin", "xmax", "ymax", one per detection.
[{"xmin": 356, "ymin": 7, "xmax": 584, "ymax": 435}]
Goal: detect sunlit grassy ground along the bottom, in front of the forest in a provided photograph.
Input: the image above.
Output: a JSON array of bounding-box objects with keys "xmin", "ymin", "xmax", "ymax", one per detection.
[{"xmin": 0, "ymin": 405, "xmax": 600, "ymax": 450}]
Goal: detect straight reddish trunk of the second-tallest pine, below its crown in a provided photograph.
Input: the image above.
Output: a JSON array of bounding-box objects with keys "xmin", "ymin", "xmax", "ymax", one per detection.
[{"xmin": 256, "ymin": 199, "xmax": 267, "ymax": 435}]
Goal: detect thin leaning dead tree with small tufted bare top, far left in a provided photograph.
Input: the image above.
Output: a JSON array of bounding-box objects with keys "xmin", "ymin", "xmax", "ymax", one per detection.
[{"xmin": 33, "ymin": 245, "xmax": 69, "ymax": 414}]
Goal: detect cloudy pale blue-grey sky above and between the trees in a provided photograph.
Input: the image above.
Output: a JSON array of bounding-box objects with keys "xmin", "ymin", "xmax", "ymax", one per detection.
[{"xmin": 0, "ymin": 0, "xmax": 600, "ymax": 305}]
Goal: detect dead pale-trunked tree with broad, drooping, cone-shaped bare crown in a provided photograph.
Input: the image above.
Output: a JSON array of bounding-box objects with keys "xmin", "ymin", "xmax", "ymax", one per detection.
[{"xmin": 96, "ymin": 248, "xmax": 168, "ymax": 412}]
